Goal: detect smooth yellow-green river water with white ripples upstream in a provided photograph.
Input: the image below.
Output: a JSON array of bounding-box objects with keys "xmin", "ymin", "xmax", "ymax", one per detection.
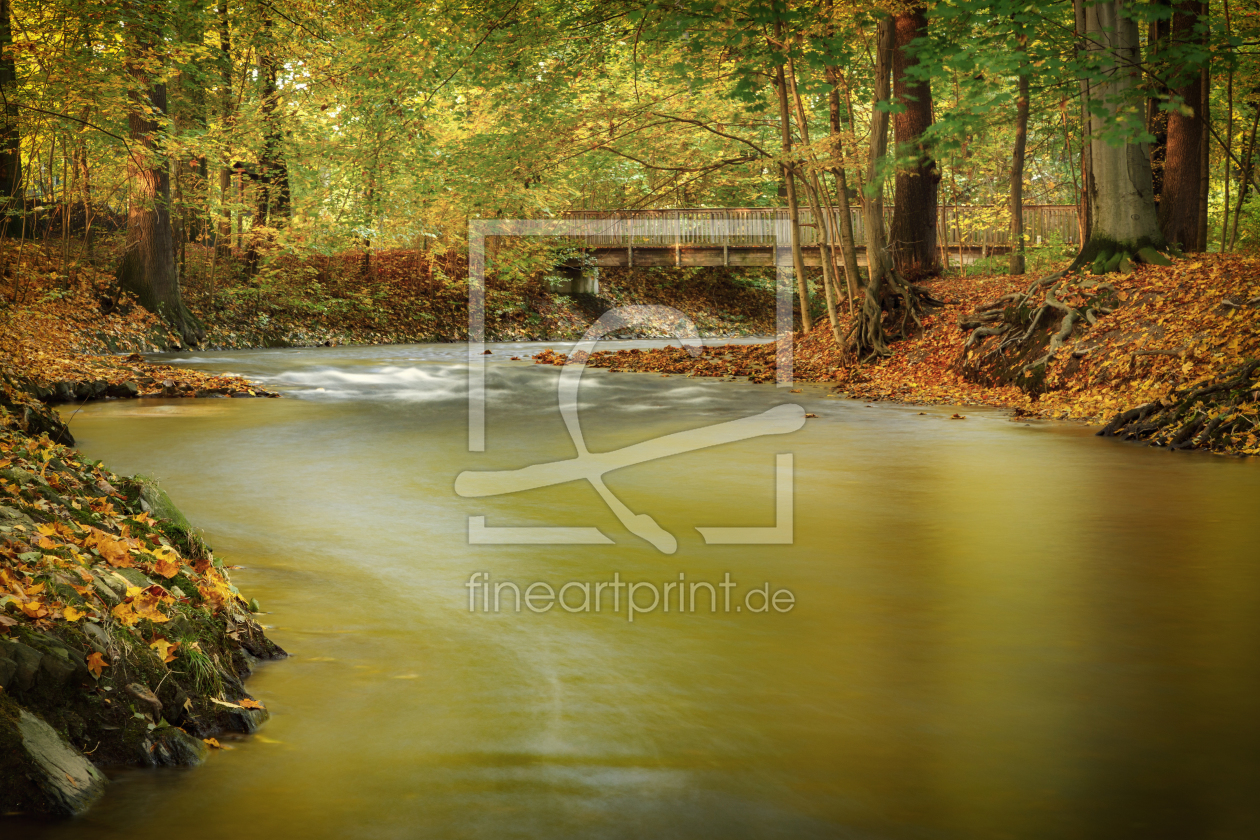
[{"xmin": 17, "ymin": 343, "xmax": 1260, "ymax": 840}]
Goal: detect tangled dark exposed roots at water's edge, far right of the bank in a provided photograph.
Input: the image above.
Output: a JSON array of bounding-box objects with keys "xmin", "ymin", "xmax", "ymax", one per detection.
[{"xmin": 1099, "ymin": 359, "xmax": 1260, "ymax": 450}]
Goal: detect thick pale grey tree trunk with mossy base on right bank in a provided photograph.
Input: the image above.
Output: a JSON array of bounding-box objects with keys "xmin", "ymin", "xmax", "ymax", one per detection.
[{"xmin": 1074, "ymin": 0, "xmax": 1164, "ymax": 266}]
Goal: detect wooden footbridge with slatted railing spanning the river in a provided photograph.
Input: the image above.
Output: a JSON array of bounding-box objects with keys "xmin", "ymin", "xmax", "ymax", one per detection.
[{"xmin": 564, "ymin": 204, "xmax": 1080, "ymax": 291}]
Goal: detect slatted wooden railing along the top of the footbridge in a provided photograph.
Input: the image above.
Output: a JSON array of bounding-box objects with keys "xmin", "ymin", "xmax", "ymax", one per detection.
[{"xmin": 564, "ymin": 204, "xmax": 1080, "ymax": 248}]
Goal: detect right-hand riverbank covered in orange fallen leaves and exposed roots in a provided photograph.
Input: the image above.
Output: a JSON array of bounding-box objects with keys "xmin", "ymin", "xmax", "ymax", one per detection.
[{"xmin": 536, "ymin": 254, "xmax": 1260, "ymax": 455}]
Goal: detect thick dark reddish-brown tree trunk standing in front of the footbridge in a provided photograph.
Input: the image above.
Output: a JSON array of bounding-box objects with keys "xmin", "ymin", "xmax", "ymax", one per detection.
[{"xmin": 890, "ymin": 6, "xmax": 940, "ymax": 280}]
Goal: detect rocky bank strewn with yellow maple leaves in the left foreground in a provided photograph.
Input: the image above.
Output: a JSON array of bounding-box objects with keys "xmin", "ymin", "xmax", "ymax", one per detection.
[{"xmin": 0, "ymin": 385, "xmax": 285, "ymax": 816}]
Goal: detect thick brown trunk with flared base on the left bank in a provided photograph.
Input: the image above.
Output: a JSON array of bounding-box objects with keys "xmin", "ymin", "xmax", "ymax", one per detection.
[{"xmin": 117, "ymin": 28, "xmax": 203, "ymax": 346}]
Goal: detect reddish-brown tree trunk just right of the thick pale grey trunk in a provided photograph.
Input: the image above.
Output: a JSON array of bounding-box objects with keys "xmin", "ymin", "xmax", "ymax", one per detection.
[{"xmin": 1159, "ymin": 0, "xmax": 1203, "ymax": 251}]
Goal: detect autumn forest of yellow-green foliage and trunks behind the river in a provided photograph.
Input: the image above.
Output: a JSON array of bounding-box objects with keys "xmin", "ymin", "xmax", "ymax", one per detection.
[{"xmin": 0, "ymin": 0, "xmax": 1260, "ymax": 353}]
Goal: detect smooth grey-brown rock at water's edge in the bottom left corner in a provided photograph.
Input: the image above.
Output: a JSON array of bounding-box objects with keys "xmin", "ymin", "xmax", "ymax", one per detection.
[{"xmin": 0, "ymin": 698, "xmax": 106, "ymax": 816}]
